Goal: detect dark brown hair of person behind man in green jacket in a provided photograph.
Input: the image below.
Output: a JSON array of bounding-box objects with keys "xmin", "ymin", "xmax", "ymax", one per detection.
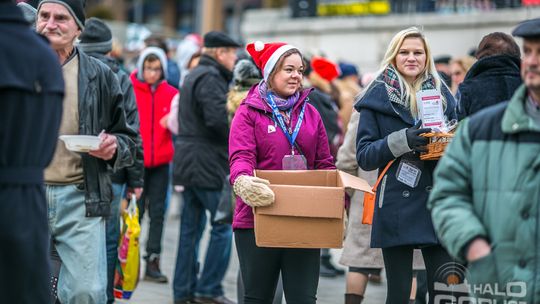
[{"xmin": 476, "ymin": 32, "xmax": 521, "ymax": 59}]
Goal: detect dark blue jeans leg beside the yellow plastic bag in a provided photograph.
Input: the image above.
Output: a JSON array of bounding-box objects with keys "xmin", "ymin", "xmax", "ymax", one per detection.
[{"xmin": 105, "ymin": 183, "xmax": 126, "ymax": 303}]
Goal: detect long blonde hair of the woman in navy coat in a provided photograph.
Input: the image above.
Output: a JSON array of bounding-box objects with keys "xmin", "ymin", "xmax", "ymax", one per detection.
[{"xmin": 361, "ymin": 26, "xmax": 446, "ymax": 118}]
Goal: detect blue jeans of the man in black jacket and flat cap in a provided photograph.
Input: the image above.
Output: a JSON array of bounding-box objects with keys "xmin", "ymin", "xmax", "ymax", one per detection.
[{"xmin": 173, "ymin": 187, "xmax": 232, "ymax": 301}]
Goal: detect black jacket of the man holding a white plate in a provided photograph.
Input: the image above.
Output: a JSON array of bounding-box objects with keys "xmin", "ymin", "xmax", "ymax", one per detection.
[{"xmin": 78, "ymin": 51, "xmax": 137, "ymax": 217}]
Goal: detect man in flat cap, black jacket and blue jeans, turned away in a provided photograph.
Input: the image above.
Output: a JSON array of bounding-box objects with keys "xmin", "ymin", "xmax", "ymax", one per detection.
[{"xmin": 173, "ymin": 32, "xmax": 240, "ymax": 303}]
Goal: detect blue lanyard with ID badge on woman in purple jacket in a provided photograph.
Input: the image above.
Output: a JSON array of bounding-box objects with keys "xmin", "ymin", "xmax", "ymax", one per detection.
[{"xmin": 267, "ymin": 93, "xmax": 307, "ymax": 170}]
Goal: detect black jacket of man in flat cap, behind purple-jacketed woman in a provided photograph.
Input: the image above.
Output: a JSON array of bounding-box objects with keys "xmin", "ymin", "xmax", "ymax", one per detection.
[{"xmin": 173, "ymin": 55, "xmax": 232, "ymax": 189}]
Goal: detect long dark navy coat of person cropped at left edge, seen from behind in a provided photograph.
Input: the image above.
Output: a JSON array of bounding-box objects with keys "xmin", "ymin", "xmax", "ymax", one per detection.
[{"xmin": 0, "ymin": 2, "xmax": 64, "ymax": 304}]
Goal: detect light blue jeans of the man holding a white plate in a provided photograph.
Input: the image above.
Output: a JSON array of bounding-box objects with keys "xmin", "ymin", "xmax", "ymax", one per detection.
[{"xmin": 46, "ymin": 185, "xmax": 107, "ymax": 304}]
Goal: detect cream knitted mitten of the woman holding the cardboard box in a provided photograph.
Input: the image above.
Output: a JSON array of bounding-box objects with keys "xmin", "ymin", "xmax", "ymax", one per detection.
[{"xmin": 233, "ymin": 175, "xmax": 275, "ymax": 207}]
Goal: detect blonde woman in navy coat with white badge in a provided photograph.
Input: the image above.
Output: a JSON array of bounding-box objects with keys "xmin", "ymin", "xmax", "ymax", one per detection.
[{"xmin": 355, "ymin": 27, "xmax": 456, "ymax": 303}]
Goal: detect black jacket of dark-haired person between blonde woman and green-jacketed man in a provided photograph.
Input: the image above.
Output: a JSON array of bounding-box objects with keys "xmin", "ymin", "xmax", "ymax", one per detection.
[{"xmin": 456, "ymin": 55, "xmax": 522, "ymax": 120}]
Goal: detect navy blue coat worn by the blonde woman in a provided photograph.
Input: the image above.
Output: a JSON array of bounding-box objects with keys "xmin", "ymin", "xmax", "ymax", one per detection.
[{"xmin": 355, "ymin": 83, "xmax": 456, "ymax": 248}]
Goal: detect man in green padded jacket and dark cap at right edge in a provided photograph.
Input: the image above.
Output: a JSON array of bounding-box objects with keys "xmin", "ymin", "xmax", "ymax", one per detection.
[{"xmin": 429, "ymin": 18, "xmax": 540, "ymax": 303}]
